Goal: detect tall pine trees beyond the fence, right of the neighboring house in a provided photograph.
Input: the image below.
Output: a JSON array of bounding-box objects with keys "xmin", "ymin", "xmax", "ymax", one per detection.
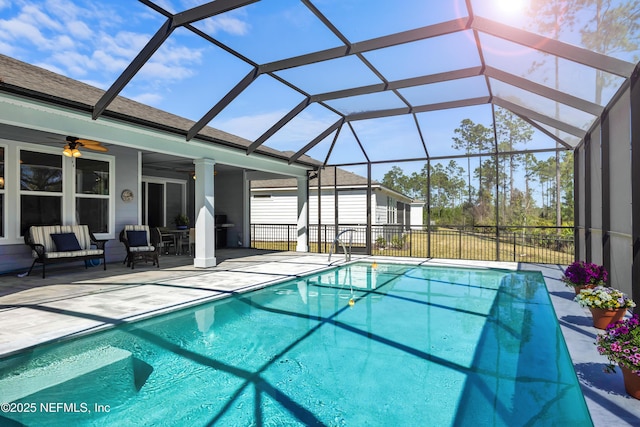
[{"xmin": 382, "ymin": 109, "xmax": 573, "ymax": 231}]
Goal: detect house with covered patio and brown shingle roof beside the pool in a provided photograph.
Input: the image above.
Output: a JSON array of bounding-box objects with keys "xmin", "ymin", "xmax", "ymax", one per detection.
[{"xmin": 0, "ymin": 55, "xmax": 317, "ymax": 272}]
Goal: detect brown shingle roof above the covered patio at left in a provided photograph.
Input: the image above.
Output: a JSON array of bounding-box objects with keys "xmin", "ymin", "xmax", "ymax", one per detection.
[{"xmin": 0, "ymin": 54, "xmax": 318, "ymax": 165}]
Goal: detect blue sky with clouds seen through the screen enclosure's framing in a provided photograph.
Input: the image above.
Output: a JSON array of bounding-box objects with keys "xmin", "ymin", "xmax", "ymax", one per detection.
[{"xmin": 0, "ymin": 0, "xmax": 632, "ymax": 191}]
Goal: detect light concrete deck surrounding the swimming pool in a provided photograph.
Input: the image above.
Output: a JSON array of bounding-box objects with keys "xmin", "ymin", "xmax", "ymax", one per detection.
[{"xmin": 0, "ymin": 249, "xmax": 640, "ymax": 427}]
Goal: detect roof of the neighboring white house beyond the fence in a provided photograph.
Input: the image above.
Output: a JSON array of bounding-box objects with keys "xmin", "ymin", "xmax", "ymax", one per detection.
[{"xmin": 251, "ymin": 167, "xmax": 411, "ymax": 200}]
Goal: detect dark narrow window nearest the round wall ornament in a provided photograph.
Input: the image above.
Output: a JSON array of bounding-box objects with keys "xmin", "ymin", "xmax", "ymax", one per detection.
[{"xmin": 76, "ymin": 158, "xmax": 110, "ymax": 233}]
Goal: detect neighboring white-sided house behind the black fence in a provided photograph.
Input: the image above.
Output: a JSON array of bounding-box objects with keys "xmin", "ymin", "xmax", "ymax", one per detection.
[{"xmin": 251, "ymin": 167, "xmax": 424, "ymax": 232}]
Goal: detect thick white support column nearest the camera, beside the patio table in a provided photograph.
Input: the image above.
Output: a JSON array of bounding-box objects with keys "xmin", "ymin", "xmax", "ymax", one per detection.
[{"xmin": 193, "ymin": 159, "xmax": 216, "ymax": 268}]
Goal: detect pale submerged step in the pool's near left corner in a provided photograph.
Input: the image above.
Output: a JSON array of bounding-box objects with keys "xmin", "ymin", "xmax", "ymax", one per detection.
[{"xmin": 0, "ymin": 346, "xmax": 151, "ymax": 403}]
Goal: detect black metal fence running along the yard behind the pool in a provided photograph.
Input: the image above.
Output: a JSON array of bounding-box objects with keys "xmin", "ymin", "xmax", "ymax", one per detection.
[{"xmin": 251, "ymin": 224, "xmax": 575, "ymax": 264}]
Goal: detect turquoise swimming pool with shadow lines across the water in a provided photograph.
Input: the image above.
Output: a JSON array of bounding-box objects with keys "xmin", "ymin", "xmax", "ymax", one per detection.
[{"xmin": 0, "ymin": 264, "xmax": 591, "ymax": 426}]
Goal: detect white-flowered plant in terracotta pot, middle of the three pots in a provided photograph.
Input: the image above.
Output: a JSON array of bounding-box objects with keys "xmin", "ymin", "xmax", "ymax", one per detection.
[{"xmin": 574, "ymin": 286, "xmax": 636, "ymax": 329}]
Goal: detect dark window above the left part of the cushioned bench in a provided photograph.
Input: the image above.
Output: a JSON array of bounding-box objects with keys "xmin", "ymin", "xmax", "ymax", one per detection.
[{"xmin": 19, "ymin": 150, "xmax": 63, "ymax": 235}]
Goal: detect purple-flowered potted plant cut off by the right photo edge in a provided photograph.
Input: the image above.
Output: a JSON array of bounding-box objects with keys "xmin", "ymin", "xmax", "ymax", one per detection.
[{"xmin": 596, "ymin": 314, "xmax": 640, "ymax": 399}]
